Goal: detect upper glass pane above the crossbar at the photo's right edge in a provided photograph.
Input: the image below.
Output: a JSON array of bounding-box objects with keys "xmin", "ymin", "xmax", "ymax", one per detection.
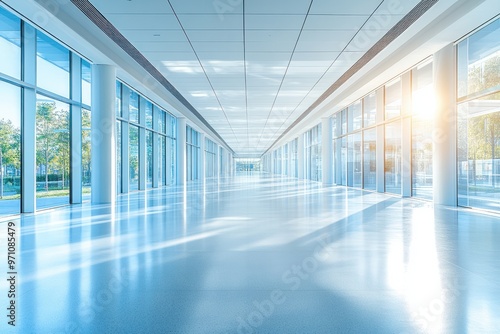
[{"xmin": 458, "ymin": 19, "xmax": 500, "ymax": 97}]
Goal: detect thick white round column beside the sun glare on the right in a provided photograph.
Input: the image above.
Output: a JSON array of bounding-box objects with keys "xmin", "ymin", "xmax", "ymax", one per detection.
[{"xmin": 432, "ymin": 44, "xmax": 457, "ymax": 206}]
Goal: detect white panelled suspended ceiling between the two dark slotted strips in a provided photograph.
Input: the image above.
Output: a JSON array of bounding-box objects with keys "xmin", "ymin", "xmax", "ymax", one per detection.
[{"xmin": 83, "ymin": 0, "xmax": 419, "ymax": 156}]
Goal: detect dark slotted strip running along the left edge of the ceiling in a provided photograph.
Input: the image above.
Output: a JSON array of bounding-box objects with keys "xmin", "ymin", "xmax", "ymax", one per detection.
[{"xmin": 71, "ymin": 0, "xmax": 234, "ymax": 153}]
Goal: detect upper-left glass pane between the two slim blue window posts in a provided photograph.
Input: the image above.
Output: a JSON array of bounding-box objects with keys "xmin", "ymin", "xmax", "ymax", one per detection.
[{"xmin": 36, "ymin": 31, "xmax": 69, "ymax": 98}]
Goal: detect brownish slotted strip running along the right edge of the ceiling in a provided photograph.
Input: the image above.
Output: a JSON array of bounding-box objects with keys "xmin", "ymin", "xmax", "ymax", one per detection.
[{"xmin": 264, "ymin": 0, "xmax": 439, "ymax": 154}]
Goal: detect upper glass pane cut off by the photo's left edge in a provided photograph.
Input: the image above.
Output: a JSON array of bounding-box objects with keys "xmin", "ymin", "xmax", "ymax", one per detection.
[{"xmin": 0, "ymin": 8, "xmax": 21, "ymax": 79}]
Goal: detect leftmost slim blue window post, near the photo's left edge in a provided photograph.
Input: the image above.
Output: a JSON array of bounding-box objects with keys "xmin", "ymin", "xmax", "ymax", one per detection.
[{"xmin": 21, "ymin": 23, "xmax": 36, "ymax": 213}]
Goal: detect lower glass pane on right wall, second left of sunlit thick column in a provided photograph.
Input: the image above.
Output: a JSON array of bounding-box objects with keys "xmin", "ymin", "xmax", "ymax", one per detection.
[{"xmin": 385, "ymin": 121, "xmax": 401, "ymax": 194}]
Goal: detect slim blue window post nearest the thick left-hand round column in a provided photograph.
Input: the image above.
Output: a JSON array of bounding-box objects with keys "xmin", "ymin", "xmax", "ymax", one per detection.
[{"xmin": 70, "ymin": 53, "xmax": 82, "ymax": 204}]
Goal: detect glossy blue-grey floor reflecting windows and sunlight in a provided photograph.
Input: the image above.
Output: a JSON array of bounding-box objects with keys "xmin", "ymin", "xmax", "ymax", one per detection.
[{"xmin": 0, "ymin": 174, "xmax": 500, "ymax": 334}]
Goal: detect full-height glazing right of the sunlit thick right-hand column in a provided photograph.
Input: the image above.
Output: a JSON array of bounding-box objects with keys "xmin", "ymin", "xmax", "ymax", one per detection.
[{"xmin": 457, "ymin": 19, "xmax": 500, "ymax": 211}]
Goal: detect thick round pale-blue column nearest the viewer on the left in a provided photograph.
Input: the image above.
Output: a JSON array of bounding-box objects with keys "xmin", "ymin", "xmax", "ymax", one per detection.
[{"xmin": 91, "ymin": 65, "xmax": 116, "ymax": 204}]
